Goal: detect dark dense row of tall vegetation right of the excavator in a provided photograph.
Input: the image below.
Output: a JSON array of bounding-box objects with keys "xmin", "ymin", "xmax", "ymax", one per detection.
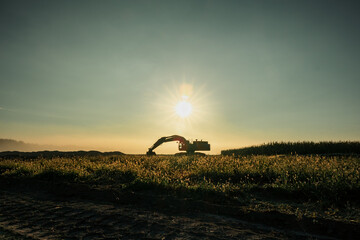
[{"xmin": 221, "ymin": 141, "xmax": 360, "ymax": 156}]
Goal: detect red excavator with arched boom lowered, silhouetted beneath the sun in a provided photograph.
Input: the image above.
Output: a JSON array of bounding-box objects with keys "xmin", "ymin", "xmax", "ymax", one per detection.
[{"xmin": 146, "ymin": 135, "xmax": 210, "ymax": 156}]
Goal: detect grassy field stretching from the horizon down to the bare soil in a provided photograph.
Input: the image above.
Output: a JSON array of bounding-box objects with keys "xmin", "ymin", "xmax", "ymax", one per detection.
[{"xmin": 0, "ymin": 155, "xmax": 360, "ymax": 238}]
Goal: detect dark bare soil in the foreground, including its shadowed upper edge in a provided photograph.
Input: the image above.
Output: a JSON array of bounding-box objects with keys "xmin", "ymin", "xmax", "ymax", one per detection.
[{"xmin": 0, "ymin": 182, "xmax": 355, "ymax": 239}]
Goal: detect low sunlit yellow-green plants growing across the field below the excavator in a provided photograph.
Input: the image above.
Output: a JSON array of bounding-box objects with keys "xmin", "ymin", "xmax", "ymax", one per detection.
[{"xmin": 0, "ymin": 155, "xmax": 360, "ymax": 220}]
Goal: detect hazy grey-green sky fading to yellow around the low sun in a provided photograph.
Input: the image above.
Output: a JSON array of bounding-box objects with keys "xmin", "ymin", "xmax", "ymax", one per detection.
[{"xmin": 0, "ymin": 0, "xmax": 360, "ymax": 154}]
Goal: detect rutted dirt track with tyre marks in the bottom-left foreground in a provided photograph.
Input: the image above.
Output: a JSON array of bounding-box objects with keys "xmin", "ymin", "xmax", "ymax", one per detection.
[{"xmin": 0, "ymin": 190, "xmax": 338, "ymax": 239}]
